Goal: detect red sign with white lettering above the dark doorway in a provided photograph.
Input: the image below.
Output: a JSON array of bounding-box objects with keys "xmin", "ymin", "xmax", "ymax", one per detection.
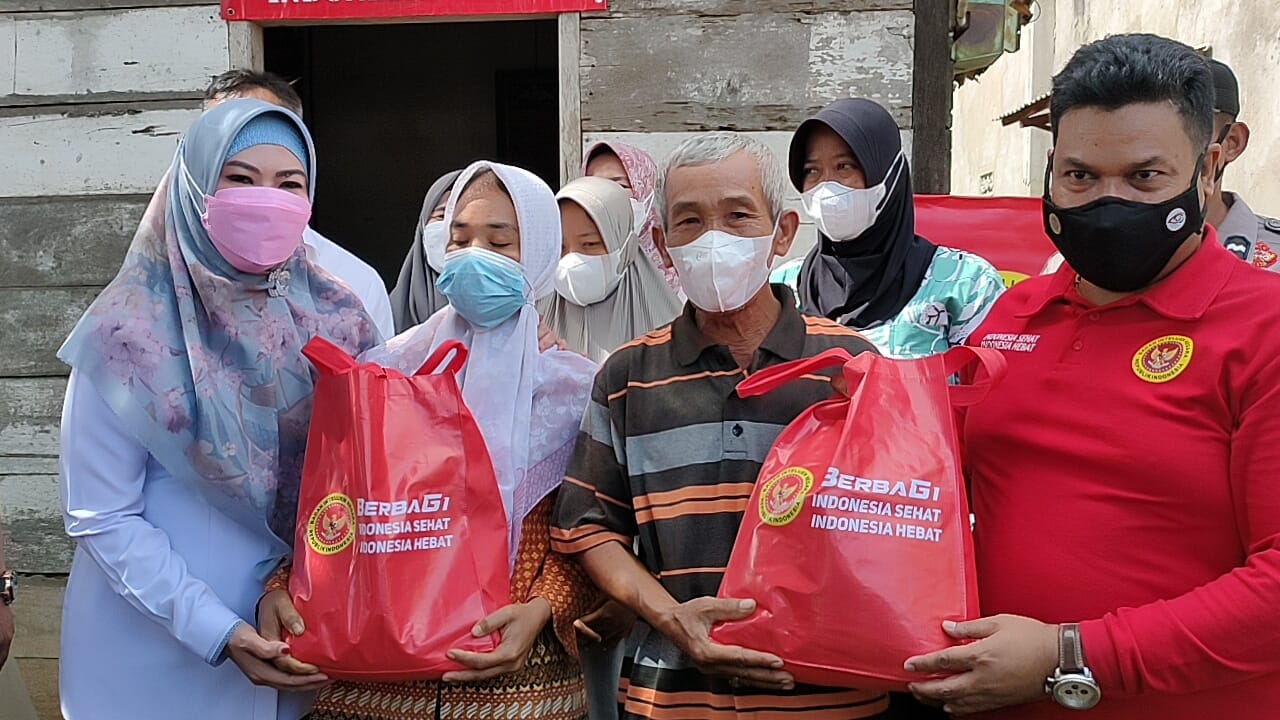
[{"xmin": 223, "ymin": 0, "xmax": 609, "ymax": 22}]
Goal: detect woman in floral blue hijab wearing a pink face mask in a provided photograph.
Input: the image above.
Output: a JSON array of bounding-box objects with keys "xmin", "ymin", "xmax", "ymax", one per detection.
[{"xmin": 59, "ymin": 100, "xmax": 378, "ymax": 720}]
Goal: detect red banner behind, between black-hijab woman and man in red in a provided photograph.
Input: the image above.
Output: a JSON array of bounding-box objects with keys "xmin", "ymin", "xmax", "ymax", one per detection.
[{"xmin": 915, "ymin": 195, "xmax": 1053, "ymax": 284}]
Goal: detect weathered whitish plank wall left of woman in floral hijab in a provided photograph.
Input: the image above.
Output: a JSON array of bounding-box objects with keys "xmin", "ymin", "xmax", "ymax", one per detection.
[{"xmin": 0, "ymin": 0, "xmax": 227, "ymax": 574}]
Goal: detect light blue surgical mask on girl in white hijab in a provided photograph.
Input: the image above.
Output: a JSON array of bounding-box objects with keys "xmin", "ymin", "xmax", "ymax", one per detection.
[{"xmin": 435, "ymin": 247, "xmax": 530, "ymax": 331}]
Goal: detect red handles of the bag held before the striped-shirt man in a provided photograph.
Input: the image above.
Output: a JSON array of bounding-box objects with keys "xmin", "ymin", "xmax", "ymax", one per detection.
[{"xmin": 737, "ymin": 346, "xmax": 1007, "ymax": 407}]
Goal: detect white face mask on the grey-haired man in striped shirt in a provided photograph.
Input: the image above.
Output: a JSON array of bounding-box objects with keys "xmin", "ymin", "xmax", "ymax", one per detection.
[{"xmin": 667, "ymin": 215, "xmax": 782, "ymax": 313}]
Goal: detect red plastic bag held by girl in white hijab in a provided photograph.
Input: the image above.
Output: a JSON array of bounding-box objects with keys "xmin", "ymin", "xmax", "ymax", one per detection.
[{"xmin": 289, "ymin": 338, "xmax": 511, "ymax": 682}]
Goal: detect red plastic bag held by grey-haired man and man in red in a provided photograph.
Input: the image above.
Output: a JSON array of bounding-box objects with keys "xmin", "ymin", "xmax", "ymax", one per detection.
[{"xmin": 712, "ymin": 347, "xmax": 1005, "ymax": 689}]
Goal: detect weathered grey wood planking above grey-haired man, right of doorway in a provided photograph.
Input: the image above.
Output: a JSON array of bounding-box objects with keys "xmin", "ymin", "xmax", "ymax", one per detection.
[{"xmin": 581, "ymin": 0, "xmax": 915, "ymax": 132}]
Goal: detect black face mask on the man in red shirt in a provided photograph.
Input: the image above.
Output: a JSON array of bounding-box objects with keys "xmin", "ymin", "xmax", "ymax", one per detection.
[{"xmin": 1043, "ymin": 155, "xmax": 1204, "ymax": 292}]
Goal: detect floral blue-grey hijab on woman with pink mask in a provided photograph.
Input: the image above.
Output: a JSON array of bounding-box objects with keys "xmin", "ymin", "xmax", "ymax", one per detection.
[{"xmin": 58, "ymin": 100, "xmax": 378, "ymax": 542}]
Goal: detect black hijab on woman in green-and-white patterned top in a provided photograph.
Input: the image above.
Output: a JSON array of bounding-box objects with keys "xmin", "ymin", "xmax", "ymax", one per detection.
[{"xmin": 788, "ymin": 99, "xmax": 937, "ymax": 328}]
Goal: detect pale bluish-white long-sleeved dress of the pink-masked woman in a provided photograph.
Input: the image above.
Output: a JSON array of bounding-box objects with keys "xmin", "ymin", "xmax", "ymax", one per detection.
[{"xmin": 59, "ymin": 372, "xmax": 311, "ymax": 720}]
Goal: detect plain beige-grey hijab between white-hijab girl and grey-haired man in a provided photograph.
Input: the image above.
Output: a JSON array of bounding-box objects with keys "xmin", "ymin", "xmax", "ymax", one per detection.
[{"xmin": 538, "ymin": 177, "xmax": 681, "ymax": 363}]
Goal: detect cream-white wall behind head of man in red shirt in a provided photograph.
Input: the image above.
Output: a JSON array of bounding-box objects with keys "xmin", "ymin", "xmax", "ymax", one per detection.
[{"xmin": 951, "ymin": 0, "xmax": 1280, "ymax": 214}]
